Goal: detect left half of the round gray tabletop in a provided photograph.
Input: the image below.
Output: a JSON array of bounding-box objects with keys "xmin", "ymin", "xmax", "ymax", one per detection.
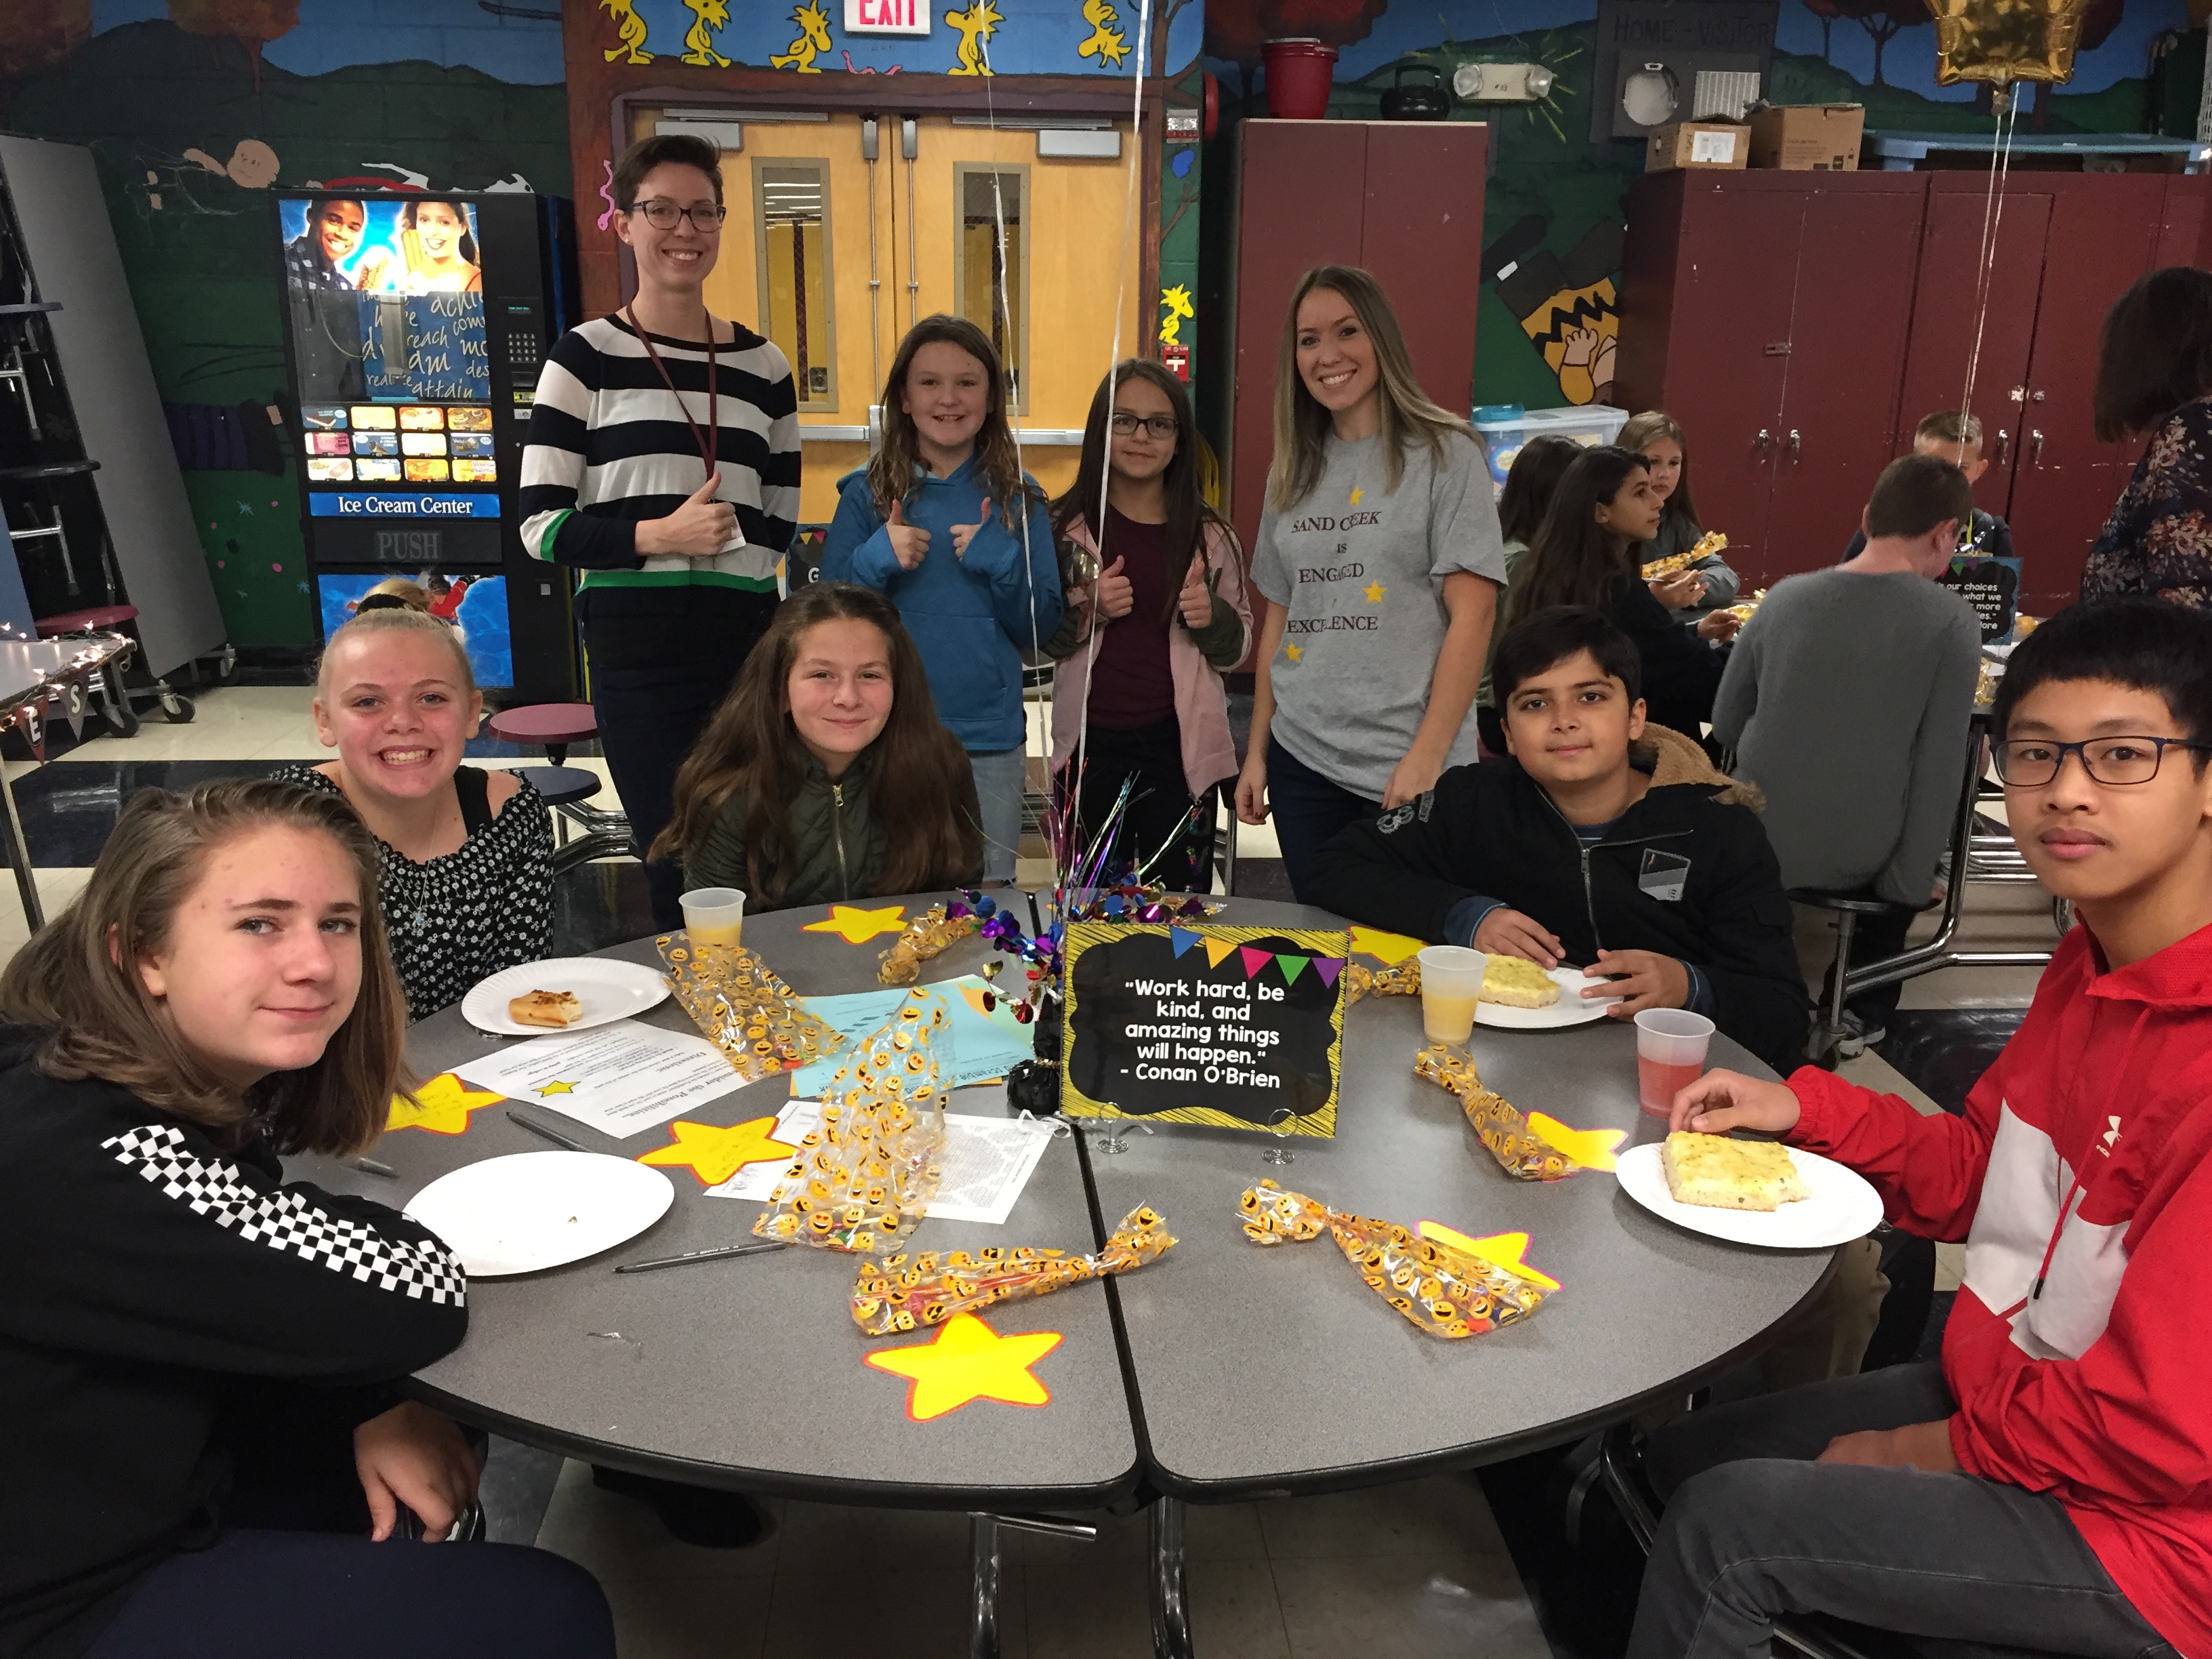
[{"xmin": 303, "ymin": 900, "xmax": 1137, "ymax": 1507}]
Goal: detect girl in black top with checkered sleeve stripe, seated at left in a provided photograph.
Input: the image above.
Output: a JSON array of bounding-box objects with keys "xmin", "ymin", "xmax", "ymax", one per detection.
[{"xmin": 0, "ymin": 779, "xmax": 615, "ymax": 1659}]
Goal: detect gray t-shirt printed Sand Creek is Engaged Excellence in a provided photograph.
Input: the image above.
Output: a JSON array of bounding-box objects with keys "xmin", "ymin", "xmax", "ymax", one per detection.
[{"xmin": 1252, "ymin": 434, "xmax": 1507, "ymax": 801}]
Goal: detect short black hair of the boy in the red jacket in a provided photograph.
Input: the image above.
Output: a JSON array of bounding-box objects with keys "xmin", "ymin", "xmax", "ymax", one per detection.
[{"xmin": 1990, "ymin": 597, "xmax": 2212, "ymax": 772}]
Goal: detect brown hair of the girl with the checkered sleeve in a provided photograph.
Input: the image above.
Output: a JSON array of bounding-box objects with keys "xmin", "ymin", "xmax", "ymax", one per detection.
[{"xmin": 0, "ymin": 779, "xmax": 411, "ymax": 1155}]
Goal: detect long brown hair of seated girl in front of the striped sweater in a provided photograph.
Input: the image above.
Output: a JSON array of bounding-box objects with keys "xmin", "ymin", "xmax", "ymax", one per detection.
[{"xmin": 646, "ymin": 581, "xmax": 982, "ymax": 905}]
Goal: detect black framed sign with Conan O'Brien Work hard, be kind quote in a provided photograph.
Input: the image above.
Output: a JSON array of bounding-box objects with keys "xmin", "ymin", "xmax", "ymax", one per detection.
[{"xmin": 1062, "ymin": 922, "xmax": 1345, "ymax": 1134}]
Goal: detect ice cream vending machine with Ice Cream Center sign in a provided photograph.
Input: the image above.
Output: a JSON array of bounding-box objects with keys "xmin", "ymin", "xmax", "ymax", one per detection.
[{"xmin": 274, "ymin": 188, "xmax": 577, "ymax": 703}]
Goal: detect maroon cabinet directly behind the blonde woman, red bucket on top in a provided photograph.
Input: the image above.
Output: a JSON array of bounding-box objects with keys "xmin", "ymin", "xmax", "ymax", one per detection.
[{"xmin": 1228, "ymin": 122, "xmax": 1489, "ymax": 566}]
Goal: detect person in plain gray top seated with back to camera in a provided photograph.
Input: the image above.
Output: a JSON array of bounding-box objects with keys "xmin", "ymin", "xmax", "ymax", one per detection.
[{"xmin": 1712, "ymin": 455, "xmax": 1982, "ymax": 1055}]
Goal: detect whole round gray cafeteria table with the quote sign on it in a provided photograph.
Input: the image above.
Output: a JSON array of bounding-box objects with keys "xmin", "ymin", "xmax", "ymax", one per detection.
[{"xmin": 299, "ymin": 896, "xmax": 1836, "ymax": 1659}]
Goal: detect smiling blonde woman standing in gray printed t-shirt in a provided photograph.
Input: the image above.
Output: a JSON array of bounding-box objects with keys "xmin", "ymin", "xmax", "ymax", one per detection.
[{"xmin": 1237, "ymin": 266, "xmax": 1507, "ymax": 894}]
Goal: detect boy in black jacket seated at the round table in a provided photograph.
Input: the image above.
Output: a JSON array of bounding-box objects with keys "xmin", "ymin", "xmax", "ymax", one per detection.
[{"xmin": 1307, "ymin": 606, "xmax": 1807, "ymax": 1066}]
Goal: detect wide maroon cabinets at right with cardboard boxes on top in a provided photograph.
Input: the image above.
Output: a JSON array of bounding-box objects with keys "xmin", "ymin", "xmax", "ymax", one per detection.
[{"xmin": 1615, "ymin": 170, "xmax": 2205, "ymax": 615}]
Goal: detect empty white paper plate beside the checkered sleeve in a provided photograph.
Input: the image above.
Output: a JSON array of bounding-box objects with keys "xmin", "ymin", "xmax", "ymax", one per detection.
[{"xmin": 407, "ymin": 1153, "xmax": 677, "ymax": 1279}]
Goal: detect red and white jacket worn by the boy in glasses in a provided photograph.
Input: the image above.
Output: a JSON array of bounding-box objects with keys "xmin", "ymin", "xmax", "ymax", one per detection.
[{"xmin": 1790, "ymin": 927, "xmax": 2212, "ymax": 1659}]
